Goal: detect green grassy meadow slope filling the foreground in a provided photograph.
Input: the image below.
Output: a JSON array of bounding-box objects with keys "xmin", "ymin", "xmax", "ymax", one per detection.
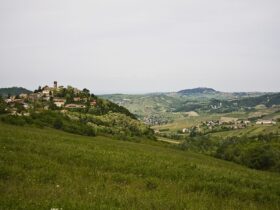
[{"xmin": 0, "ymin": 123, "xmax": 280, "ymax": 210}]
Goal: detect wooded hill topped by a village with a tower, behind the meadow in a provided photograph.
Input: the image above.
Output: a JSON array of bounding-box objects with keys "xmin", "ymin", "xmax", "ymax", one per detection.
[{"xmin": 0, "ymin": 81, "xmax": 154, "ymax": 140}]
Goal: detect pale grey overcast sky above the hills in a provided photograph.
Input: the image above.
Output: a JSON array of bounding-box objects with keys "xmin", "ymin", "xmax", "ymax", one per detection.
[{"xmin": 0, "ymin": 0, "xmax": 280, "ymax": 94}]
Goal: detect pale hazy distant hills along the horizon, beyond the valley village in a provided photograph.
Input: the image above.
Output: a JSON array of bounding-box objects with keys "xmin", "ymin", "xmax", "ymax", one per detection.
[{"xmin": 101, "ymin": 88, "xmax": 280, "ymax": 125}]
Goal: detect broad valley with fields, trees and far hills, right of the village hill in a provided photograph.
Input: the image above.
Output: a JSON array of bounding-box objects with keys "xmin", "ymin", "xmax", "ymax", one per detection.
[{"xmin": 102, "ymin": 88, "xmax": 280, "ymax": 172}]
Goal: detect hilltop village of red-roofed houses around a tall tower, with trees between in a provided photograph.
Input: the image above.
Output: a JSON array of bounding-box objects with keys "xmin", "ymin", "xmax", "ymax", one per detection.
[{"xmin": 4, "ymin": 81, "xmax": 97, "ymax": 116}]
